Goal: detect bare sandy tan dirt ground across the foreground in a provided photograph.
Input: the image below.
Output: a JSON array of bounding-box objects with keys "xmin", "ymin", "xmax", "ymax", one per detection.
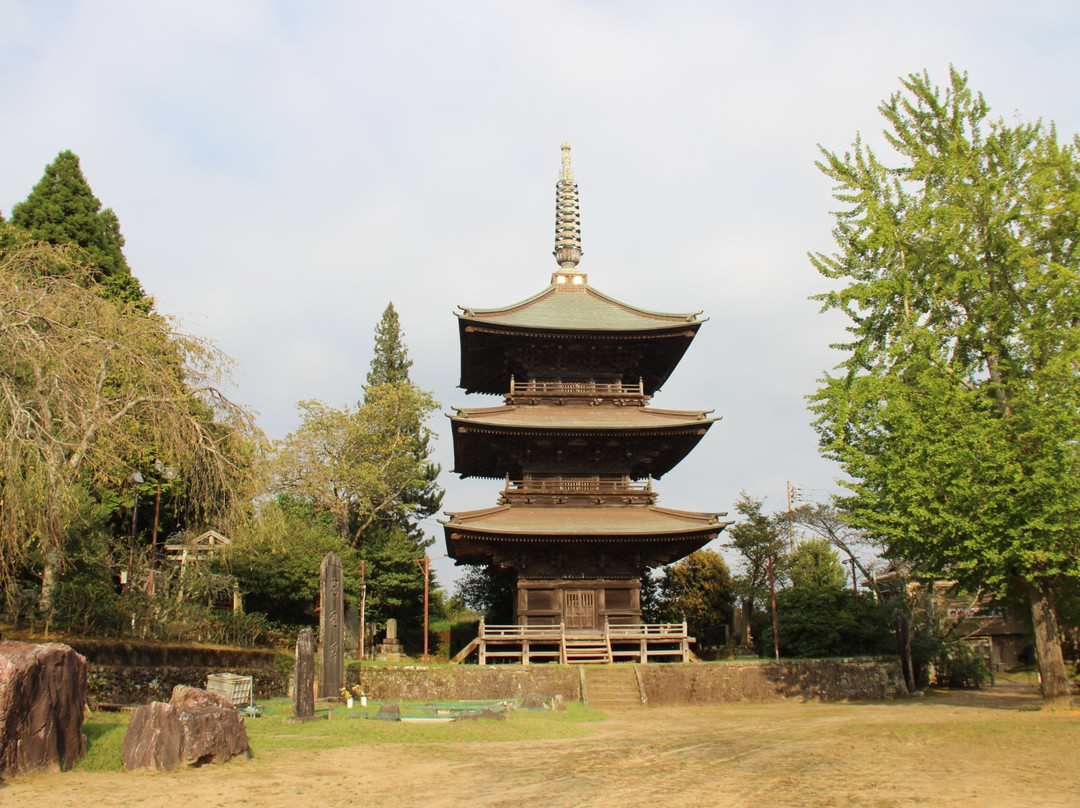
[{"xmin": 0, "ymin": 688, "xmax": 1080, "ymax": 808}]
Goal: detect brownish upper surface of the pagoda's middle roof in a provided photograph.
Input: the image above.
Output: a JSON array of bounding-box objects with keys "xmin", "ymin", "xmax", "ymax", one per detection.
[{"xmin": 450, "ymin": 404, "xmax": 719, "ymax": 432}]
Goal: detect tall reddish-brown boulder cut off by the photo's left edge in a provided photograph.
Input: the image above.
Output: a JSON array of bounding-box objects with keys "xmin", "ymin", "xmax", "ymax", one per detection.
[{"xmin": 0, "ymin": 642, "xmax": 86, "ymax": 777}]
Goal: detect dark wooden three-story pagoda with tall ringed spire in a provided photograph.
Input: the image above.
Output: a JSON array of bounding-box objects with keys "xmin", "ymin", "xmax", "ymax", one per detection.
[{"xmin": 443, "ymin": 143, "xmax": 729, "ymax": 631}]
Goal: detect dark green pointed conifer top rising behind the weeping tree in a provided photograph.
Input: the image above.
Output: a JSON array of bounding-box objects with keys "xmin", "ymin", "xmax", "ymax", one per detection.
[{"xmin": 11, "ymin": 151, "xmax": 149, "ymax": 309}]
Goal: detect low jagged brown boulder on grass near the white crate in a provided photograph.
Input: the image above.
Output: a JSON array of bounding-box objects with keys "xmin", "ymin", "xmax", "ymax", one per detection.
[{"xmin": 121, "ymin": 685, "xmax": 247, "ymax": 771}]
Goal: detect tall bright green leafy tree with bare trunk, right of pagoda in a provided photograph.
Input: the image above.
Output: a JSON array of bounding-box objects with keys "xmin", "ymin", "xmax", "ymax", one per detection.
[{"xmin": 811, "ymin": 69, "xmax": 1080, "ymax": 705}]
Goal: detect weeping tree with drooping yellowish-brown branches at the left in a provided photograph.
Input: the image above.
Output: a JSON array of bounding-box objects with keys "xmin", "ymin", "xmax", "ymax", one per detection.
[{"xmin": 0, "ymin": 225, "xmax": 260, "ymax": 616}]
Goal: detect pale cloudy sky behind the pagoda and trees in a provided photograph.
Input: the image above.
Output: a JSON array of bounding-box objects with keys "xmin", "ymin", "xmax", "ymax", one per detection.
[{"xmin": 0, "ymin": 0, "xmax": 1080, "ymax": 584}]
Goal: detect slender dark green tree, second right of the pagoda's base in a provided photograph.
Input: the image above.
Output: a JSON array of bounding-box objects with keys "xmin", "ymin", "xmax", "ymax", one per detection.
[{"xmin": 728, "ymin": 491, "xmax": 787, "ymax": 642}]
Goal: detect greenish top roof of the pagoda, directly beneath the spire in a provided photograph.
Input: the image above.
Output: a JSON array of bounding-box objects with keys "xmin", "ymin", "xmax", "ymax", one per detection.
[{"xmin": 457, "ymin": 284, "xmax": 707, "ymax": 333}]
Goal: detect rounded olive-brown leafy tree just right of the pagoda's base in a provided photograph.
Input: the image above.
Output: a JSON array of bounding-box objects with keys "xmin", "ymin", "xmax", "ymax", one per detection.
[{"xmin": 660, "ymin": 550, "xmax": 734, "ymax": 645}]
